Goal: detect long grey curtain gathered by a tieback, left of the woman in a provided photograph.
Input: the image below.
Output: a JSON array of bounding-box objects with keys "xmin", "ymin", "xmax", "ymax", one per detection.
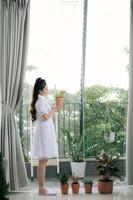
[{"xmin": 0, "ymin": 0, "xmax": 30, "ymax": 190}]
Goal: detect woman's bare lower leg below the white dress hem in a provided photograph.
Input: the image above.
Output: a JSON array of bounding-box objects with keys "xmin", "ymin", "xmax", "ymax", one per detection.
[{"xmin": 38, "ymin": 159, "xmax": 48, "ymax": 193}]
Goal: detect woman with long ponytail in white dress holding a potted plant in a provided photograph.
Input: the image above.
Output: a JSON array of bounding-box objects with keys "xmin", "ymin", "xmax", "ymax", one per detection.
[{"xmin": 30, "ymin": 78, "xmax": 58, "ymax": 195}]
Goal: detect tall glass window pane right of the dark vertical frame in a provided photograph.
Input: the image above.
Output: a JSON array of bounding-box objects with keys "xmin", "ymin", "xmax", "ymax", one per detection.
[{"xmin": 84, "ymin": 0, "xmax": 130, "ymax": 181}]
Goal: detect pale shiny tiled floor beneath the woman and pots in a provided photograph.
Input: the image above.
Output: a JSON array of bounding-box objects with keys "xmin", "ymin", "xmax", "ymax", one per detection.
[{"xmin": 10, "ymin": 181, "xmax": 133, "ymax": 200}]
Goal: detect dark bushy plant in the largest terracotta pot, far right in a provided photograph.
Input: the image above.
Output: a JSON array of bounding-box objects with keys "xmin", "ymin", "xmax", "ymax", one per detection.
[{"xmin": 96, "ymin": 152, "xmax": 120, "ymax": 194}]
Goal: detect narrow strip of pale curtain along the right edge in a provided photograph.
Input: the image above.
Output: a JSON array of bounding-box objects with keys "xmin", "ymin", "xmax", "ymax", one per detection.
[{"xmin": 126, "ymin": 0, "xmax": 133, "ymax": 185}]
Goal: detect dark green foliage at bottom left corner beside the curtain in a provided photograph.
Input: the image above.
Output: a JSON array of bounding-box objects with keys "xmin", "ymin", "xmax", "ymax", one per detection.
[{"xmin": 0, "ymin": 153, "xmax": 9, "ymax": 199}]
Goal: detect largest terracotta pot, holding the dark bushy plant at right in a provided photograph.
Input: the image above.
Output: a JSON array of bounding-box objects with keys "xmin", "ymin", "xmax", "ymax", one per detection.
[{"xmin": 97, "ymin": 180, "xmax": 113, "ymax": 194}]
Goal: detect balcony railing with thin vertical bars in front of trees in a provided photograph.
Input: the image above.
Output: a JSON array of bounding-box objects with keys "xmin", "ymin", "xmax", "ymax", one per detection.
[{"xmin": 16, "ymin": 103, "xmax": 126, "ymax": 162}]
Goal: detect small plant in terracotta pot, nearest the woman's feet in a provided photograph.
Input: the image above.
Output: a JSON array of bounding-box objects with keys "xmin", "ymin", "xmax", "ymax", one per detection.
[{"xmin": 58, "ymin": 173, "xmax": 69, "ymax": 194}]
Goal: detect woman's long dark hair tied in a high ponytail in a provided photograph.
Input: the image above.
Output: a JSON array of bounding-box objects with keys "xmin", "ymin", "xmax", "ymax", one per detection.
[{"xmin": 30, "ymin": 77, "xmax": 47, "ymax": 121}]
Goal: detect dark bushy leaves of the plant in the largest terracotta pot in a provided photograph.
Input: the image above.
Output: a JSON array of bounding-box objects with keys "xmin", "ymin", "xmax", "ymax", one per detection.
[{"xmin": 96, "ymin": 152, "xmax": 120, "ymax": 182}]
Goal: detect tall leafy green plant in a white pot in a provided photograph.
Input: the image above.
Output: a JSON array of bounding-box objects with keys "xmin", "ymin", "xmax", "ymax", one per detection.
[{"xmin": 63, "ymin": 129, "xmax": 86, "ymax": 178}]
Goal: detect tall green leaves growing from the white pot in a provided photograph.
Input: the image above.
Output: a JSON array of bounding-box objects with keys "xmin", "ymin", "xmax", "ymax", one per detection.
[{"xmin": 63, "ymin": 129, "xmax": 83, "ymax": 162}]
